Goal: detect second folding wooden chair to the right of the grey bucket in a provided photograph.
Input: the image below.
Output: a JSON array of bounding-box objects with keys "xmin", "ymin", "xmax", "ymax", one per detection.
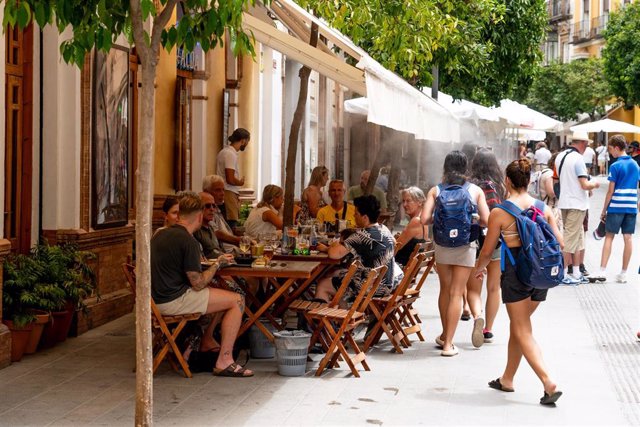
[{"xmin": 362, "ymin": 255, "xmax": 424, "ymax": 353}]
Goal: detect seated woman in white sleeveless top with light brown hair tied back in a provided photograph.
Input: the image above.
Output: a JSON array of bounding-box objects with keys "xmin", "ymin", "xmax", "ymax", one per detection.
[{"xmin": 244, "ymin": 184, "xmax": 284, "ymax": 239}]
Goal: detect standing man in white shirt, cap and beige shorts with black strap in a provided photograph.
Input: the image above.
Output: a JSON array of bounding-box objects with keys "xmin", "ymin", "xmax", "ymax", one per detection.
[{"xmin": 556, "ymin": 132, "xmax": 600, "ymax": 285}]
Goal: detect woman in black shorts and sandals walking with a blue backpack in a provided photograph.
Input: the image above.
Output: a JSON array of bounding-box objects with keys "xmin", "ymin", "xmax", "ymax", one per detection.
[{"xmin": 474, "ymin": 159, "xmax": 564, "ymax": 405}]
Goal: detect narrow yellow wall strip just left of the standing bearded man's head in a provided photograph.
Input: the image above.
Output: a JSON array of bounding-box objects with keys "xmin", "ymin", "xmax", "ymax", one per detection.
[{"xmin": 206, "ymin": 47, "xmax": 226, "ymax": 175}]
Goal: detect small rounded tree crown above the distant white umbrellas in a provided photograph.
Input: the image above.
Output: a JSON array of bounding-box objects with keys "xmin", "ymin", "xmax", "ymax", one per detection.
[{"xmin": 527, "ymin": 58, "xmax": 613, "ymax": 121}]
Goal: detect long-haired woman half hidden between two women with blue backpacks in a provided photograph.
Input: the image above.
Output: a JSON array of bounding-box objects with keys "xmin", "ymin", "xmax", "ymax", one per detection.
[{"xmin": 467, "ymin": 149, "xmax": 506, "ymax": 348}]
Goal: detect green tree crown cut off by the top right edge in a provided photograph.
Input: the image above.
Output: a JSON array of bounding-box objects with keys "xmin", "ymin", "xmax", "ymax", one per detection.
[{"xmin": 602, "ymin": 1, "xmax": 640, "ymax": 106}]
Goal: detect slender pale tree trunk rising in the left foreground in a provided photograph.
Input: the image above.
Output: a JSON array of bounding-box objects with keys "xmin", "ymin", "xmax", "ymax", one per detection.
[{"xmin": 135, "ymin": 61, "xmax": 156, "ymax": 426}]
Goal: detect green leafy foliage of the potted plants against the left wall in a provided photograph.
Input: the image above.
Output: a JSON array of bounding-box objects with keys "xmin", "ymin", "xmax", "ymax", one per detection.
[{"xmin": 2, "ymin": 243, "xmax": 95, "ymax": 326}]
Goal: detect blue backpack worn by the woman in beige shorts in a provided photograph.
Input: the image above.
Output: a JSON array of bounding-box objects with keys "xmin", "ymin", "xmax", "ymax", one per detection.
[{"xmin": 433, "ymin": 182, "xmax": 480, "ymax": 248}]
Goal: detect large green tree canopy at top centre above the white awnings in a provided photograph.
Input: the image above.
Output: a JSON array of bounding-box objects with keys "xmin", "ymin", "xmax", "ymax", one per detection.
[{"xmin": 296, "ymin": 0, "xmax": 547, "ymax": 104}]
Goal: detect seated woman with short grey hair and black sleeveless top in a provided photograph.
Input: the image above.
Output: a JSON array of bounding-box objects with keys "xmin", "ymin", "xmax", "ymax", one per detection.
[{"xmin": 395, "ymin": 187, "xmax": 429, "ymax": 266}]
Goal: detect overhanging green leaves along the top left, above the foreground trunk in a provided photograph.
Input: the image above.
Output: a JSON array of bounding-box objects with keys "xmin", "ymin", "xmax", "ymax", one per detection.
[{"xmin": 3, "ymin": 0, "xmax": 255, "ymax": 67}]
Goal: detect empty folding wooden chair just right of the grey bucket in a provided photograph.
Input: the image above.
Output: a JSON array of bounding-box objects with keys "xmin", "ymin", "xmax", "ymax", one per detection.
[{"xmin": 307, "ymin": 266, "xmax": 387, "ymax": 377}]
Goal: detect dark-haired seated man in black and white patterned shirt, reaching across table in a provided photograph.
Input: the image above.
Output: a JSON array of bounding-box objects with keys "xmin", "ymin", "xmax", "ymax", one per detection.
[{"xmin": 316, "ymin": 195, "xmax": 401, "ymax": 302}]
